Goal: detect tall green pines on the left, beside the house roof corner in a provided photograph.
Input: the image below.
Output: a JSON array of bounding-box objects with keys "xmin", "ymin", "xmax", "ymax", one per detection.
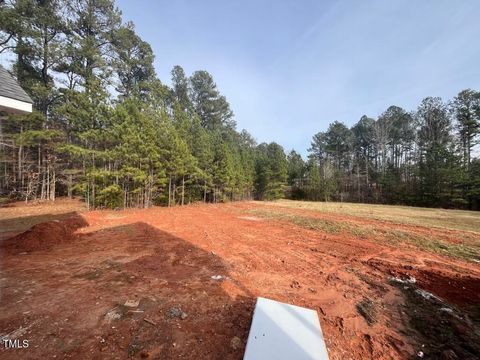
[{"xmin": 0, "ymin": 0, "xmax": 287, "ymax": 208}]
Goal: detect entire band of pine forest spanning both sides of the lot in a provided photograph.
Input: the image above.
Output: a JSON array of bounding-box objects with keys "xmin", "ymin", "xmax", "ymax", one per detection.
[{"xmin": 0, "ymin": 0, "xmax": 480, "ymax": 209}]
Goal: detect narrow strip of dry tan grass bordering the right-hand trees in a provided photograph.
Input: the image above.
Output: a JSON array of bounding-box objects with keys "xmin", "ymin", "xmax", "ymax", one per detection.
[{"xmin": 265, "ymin": 200, "xmax": 480, "ymax": 233}]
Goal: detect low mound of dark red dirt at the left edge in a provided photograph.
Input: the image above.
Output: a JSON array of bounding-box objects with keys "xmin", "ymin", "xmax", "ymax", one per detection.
[{"xmin": 1, "ymin": 215, "xmax": 88, "ymax": 254}]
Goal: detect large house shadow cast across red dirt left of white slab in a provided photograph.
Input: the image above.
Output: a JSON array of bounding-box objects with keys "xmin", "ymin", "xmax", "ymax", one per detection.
[{"xmin": 0, "ymin": 219, "xmax": 255, "ymax": 359}]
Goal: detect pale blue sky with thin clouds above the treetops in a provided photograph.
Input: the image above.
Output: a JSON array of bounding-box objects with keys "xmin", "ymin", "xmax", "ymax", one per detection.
[{"xmin": 117, "ymin": 0, "xmax": 480, "ymax": 154}]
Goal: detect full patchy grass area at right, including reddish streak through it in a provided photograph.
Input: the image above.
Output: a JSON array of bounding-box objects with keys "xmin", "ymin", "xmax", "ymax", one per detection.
[{"xmin": 248, "ymin": 200, "xmax": 480, "ymax": 263}]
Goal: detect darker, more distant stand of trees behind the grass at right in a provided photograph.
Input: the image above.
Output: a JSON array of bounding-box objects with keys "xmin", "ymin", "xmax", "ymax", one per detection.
[{"xmin": 288, "ymin": 90, "xmax": 480, "ymax": 210}]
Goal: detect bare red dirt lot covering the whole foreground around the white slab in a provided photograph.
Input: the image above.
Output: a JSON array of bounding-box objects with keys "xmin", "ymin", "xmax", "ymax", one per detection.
[{"xmin": 0, "ymin": 200, "xmax": 480, "ymax": 359}]
